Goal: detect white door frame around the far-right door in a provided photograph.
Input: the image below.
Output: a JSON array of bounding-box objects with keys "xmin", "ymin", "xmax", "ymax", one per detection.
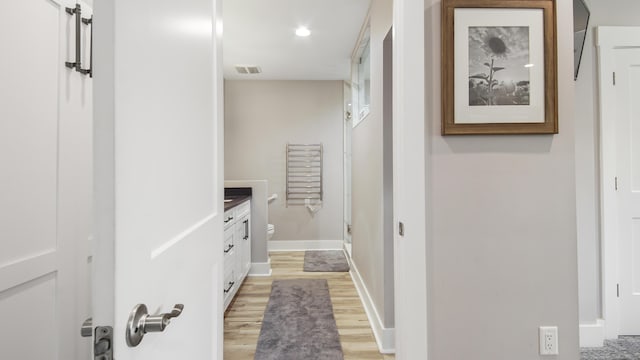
[{"xmin": 596, "ymin": 26, "xmax": 640, "ymax": 339}]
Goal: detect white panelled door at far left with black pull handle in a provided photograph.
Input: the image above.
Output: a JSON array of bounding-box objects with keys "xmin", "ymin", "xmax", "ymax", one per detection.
[{"xmin": 0, "ymin": 0, "xmax": 92, "ymax": 360}]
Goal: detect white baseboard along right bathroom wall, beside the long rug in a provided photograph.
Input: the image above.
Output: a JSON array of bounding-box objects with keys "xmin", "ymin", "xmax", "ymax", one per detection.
[{"xmin": 347, "ymin": 256, "xmax": 396, "ymax": 354}]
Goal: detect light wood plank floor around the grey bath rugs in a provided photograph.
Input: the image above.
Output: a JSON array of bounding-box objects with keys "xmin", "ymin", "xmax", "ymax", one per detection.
[{"xmin": 224, "ymin": 252, "xmax": 395, "ymax": 360}]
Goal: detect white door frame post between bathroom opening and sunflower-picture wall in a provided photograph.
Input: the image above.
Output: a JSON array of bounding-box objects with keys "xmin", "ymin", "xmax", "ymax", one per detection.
[{"xmin": 393, "ymin": 0, "xmax": 424, "ymax": 360}]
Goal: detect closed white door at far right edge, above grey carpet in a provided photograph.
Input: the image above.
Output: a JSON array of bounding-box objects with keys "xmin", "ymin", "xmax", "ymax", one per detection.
[{"xmin": 616, "ymin": 48, "xmax": 640, "ymax": 335}]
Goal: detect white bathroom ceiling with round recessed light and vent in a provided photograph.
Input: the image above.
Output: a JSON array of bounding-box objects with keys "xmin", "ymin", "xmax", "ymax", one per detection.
[{"xmin": 223, "ymin": 0, "xmax": 370, "ymax": 80}]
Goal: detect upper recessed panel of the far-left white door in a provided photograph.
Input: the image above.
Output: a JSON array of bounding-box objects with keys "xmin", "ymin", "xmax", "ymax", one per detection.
[{"xmin": 0, "ymin": 0, "xmax": 59, "ymax": 266}]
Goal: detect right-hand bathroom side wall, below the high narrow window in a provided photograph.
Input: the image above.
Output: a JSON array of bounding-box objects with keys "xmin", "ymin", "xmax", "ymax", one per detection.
[{"xmin": 352, "ymin": 0, "xmax": 394, "ymax": 328}]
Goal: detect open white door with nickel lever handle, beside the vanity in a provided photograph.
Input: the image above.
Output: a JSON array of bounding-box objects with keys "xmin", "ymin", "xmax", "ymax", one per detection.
[{"xmin": 93, "ymin": 0, "xmax": 224, "ymax": 360}]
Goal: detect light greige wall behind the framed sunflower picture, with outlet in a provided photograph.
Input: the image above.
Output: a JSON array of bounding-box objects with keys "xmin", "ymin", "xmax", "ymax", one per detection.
[{"xmin": 425, "ymin": 0, "xmax": 579, "ymax": 360}]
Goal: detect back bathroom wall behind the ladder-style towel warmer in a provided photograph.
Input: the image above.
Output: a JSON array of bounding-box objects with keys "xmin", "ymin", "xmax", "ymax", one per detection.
[{"xmin": 225, "ymin": 80, "xmax": 343, "ymax": 240}]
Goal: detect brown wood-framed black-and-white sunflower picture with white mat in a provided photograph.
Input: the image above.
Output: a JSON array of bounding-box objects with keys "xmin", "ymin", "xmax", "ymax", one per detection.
[{"xmin": 442, "ymin": 0, "xmax": 558, "ymax": 135}]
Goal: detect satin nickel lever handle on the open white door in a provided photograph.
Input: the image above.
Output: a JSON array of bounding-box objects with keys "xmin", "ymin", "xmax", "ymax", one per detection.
[{"xmin": 125, "ymin": 304, "xmax": 184, "ymax": 347}]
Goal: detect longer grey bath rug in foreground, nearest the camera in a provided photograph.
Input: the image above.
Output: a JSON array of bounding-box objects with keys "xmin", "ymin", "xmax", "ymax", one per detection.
[{"xmin": 254, "ymin": 279, "xmax": 344, "ymax": 360}]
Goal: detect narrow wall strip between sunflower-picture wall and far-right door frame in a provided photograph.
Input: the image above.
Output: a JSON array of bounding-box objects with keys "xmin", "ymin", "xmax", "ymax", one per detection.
[{"xmin": 575, "ymin": 0, "xmax": 640, "ymax": 323}]
